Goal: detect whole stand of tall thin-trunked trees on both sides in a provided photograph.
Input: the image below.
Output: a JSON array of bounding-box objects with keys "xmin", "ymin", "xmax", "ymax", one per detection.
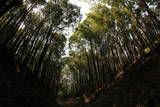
[{"xmin": 0, "ymin": 0, "xmax": 160, "ymax": 105}]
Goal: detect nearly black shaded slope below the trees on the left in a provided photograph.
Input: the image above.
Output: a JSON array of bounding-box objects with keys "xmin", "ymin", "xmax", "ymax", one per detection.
[{"xmin": 0, "ymin": 48, "xmax": 57, "ymax": 107}]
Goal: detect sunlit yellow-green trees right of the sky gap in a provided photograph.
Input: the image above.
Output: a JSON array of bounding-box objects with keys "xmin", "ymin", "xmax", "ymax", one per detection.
[{"xmin": 68, "ymin": 0, "xmax": 159, "ymax": 96}]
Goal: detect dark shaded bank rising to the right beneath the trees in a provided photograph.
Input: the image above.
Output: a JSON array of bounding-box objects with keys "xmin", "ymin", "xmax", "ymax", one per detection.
[{"xmin": 89, "ymin": 54, "xmax": 160, "ymax": 107}]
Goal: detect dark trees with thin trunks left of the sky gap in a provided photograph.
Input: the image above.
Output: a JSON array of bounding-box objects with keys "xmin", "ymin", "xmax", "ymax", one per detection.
[{"xmin": 0, "ymin": 0, "xmax": 80, "ymax": 94}]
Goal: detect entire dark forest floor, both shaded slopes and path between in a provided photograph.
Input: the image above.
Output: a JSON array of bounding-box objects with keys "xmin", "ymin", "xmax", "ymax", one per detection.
[{"xmin": 0, "ymin": 46, "xmax": 160, "ymax": 107}]
